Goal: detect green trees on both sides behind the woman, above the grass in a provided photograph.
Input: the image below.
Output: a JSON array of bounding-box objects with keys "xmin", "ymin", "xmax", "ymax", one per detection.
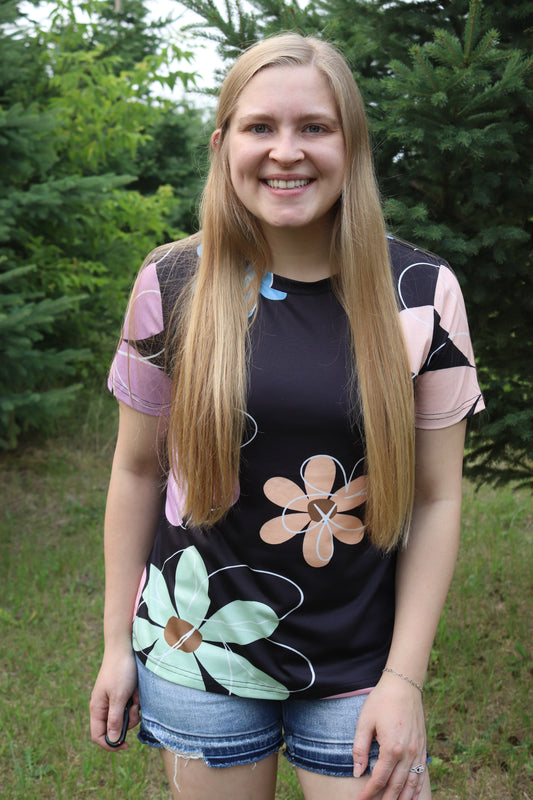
[{"xmin": 0, "ymin": 0, "xmax": 533, "ymax": 478}]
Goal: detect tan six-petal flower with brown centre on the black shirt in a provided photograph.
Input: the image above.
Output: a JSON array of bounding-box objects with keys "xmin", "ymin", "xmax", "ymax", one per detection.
[{"xmin": 260, "ymin": 456, "xmax": 366, "ymax": 567}]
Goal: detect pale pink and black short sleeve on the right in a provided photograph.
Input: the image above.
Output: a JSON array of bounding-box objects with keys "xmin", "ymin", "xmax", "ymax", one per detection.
[{"xmin": 399, "ymin": 263, "xmax": 485, "ymax": 430}]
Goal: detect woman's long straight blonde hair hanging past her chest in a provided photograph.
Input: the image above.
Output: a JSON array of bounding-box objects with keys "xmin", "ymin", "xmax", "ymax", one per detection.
[{"xmin": 164, "ymin": 33, "xmax": 414, "ymax": 550}]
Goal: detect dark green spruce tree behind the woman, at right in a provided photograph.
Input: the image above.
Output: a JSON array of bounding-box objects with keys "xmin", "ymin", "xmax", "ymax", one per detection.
[{"xmin": 373, "ymin": 0, "xmax": 533, "ymax": 484}]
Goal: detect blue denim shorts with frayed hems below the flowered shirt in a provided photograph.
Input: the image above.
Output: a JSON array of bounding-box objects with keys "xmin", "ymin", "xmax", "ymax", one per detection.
[{"xmin": 137, "ymin": 659, "xmax": 379, "ymax": 777}]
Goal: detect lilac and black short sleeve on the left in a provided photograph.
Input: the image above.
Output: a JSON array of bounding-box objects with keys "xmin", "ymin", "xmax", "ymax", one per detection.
[{"xmin": 108, "ymin": 263, "xmax": 172, "ymax": 416}]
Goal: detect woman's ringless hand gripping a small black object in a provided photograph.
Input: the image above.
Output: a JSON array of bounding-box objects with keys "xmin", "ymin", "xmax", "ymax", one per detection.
[{"xmin": 89, "ymin": 649, "xmax": 139, "ymax": 750}]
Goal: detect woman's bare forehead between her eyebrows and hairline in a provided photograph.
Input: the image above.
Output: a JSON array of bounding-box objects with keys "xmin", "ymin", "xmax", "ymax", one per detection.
[{"xmin": 232, "ymin": 64, "xmax": 339, "ymax": 119}]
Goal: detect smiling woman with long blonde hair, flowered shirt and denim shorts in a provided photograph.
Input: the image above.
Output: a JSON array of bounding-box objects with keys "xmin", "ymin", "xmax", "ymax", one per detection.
[{"xmin": 91, "ymin": 34, "xmax": 483, "ymax": 800}]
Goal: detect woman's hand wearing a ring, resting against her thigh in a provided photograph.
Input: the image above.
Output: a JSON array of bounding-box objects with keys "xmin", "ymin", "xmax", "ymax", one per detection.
[{"xmin": 353, "ymin": 674, "xmax": 426, "ymax": 800}]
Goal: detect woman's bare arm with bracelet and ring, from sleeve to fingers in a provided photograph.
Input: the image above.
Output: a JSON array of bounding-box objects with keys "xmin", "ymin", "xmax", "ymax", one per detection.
[{"xmin": 354, "ymin": 422, "xmax": 466, "ymax": 800}]
